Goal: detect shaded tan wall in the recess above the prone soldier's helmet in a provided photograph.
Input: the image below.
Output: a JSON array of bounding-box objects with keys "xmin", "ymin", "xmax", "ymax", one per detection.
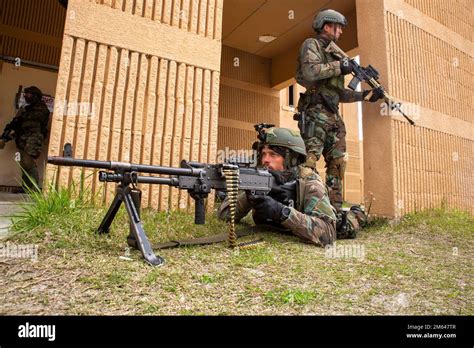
[{"xmin": 218, "ymin": 46, "xmax": 280, "ymax": 155}]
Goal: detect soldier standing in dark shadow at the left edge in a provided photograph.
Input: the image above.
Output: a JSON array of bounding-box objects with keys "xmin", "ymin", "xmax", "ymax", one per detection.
[{"xmin": 0, "ymin": 86, "xmax": 49, "ymax": 189}]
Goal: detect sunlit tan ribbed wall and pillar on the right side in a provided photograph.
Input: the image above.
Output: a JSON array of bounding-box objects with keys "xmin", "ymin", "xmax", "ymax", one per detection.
[{"xmin": 356, "ymin": 0, "xmax": 474, "ymax": 216}]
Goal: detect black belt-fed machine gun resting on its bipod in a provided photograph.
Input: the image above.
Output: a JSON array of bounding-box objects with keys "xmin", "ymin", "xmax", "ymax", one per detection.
[{"xmin": 48, "ymin": 144, "xmax": 296, "ymax": 266}]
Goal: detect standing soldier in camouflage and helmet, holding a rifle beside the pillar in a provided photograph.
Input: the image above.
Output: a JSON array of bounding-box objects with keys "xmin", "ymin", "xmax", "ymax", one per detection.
[{"xmin": 296, "ymin": 10, "xmax": 382, "ymax": 211}]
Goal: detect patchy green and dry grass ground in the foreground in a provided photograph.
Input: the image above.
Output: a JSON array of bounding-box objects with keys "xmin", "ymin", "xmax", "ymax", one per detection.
[{"xmin": 0, "ymin": 187, "xmax": 474, "ymax": 315}]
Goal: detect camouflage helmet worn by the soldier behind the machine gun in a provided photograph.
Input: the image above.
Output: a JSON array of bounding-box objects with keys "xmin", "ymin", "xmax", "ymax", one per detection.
[{"xmin": 258, "ymin": 127, "xmax": 306, "ymax": 167}]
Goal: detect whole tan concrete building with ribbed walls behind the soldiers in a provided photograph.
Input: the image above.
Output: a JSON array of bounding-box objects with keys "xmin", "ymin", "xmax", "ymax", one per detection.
[{"xmin": 0, "ymin": 0, "xmax": 474, "ymax": 216}]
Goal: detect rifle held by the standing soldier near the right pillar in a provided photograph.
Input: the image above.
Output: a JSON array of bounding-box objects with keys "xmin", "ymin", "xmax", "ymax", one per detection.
[{"xmin": 326, "ymin": 41, "xmax": 415, "ymax": 125}]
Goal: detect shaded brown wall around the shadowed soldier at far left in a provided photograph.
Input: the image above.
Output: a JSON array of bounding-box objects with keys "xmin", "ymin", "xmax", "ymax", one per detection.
[{"xmin": 0, "ymin": 63, "xmax": 58, "ymax": 186}]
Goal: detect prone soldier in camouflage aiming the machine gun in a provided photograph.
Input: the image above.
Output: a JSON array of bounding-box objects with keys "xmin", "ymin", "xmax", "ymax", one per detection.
[{"xmin": 218, "ymin": 127, "xmax": 348, "ymax": 246}]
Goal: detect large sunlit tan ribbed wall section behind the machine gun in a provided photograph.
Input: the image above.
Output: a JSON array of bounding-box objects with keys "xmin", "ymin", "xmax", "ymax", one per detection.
[{"xmin": 47, "ymin": 0, "xmax": 222, "ymax": 209}]
